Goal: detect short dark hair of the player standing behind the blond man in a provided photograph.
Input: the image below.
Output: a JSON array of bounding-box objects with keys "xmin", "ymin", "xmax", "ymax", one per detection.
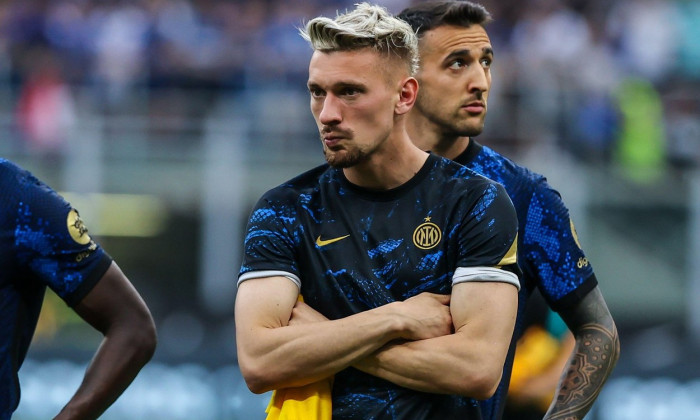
[{"xmin": 397, "ymin": 0, "xmax": 492, "ymax": 37}]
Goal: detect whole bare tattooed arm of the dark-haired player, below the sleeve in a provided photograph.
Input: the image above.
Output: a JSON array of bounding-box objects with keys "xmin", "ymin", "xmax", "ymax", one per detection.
[{"xmin": 544, "ymin": 287, "xmax": 620, "ymax": 420}]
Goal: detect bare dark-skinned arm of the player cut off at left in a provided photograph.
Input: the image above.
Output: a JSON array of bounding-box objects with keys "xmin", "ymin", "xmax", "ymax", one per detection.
[{"xmin": 55, "ymin": 262, "xmax": 156, "ymax": 420}]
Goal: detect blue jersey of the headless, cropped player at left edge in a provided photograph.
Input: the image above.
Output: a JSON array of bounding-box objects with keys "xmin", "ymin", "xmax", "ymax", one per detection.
[{"xmin": 0, "ymin": 159, "xmax": 112, "ymax": 420}]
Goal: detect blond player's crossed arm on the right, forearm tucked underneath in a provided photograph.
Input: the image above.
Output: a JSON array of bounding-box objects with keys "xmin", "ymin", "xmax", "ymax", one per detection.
[{"xmin": 355, "ymin": 282, "xmax": 517, "ymax": 399}]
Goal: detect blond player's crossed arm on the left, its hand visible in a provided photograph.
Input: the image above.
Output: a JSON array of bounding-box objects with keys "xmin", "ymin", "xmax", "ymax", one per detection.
[{"xmin": 235, "ymin": 276, "xmax": 450, "ymax": 393}]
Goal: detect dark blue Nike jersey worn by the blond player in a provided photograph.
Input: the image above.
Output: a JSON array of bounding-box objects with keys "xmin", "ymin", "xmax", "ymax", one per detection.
[{"xmin": 239, "ymin": 155, "xmax": 519, "ymax": 420}]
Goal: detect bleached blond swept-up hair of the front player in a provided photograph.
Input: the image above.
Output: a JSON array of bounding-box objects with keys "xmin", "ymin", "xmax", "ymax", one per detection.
[{"xmin": 299, "ymin": 3, "xmax": 418, "ymax": 76}]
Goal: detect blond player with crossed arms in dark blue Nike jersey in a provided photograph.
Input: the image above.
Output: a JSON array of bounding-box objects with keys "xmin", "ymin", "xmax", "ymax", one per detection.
[{"xmin": 235, "ymin": 3, "xmax": 519, "ymax": 420}]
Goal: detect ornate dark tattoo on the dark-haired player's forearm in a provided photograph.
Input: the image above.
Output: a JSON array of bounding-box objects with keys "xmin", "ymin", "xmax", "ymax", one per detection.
[{"xmin": 546, "ymin": 324, "xmax": 620, "ymax": 420}]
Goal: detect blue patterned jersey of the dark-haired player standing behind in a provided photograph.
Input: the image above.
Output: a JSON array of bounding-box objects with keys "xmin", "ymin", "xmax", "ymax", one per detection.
[{"xmin": 455, "ymin": 139, "xmax": 598, "ymax": 420}]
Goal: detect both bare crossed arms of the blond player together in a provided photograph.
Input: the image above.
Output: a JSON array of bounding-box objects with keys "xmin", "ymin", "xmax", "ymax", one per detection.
[{"xmin": 236, "ymin": 277, "xmax": 517, "ymax": 398}]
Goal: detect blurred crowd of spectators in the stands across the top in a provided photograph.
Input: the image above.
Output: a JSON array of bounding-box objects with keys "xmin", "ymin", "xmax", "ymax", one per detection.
[{"xmin": 0, "ymin": 0, "xmax": 700, "ymax": 167}]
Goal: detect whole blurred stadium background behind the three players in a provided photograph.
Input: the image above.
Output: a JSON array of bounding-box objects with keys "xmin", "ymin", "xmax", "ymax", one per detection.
[{"xmin": 0, "ymin": 0, "xmax": 700, "ymax": 420}]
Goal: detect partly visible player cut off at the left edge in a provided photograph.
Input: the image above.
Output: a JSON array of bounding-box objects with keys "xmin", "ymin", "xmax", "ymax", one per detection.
[{"xmin": 0, "ymin": 159, "xmax": 156, "ymax": 420}]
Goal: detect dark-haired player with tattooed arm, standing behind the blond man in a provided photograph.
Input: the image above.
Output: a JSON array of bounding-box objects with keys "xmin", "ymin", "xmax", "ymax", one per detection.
[{"xmin": 398, "ymin": 1, "xmax": 620, "ymax": 420}]
